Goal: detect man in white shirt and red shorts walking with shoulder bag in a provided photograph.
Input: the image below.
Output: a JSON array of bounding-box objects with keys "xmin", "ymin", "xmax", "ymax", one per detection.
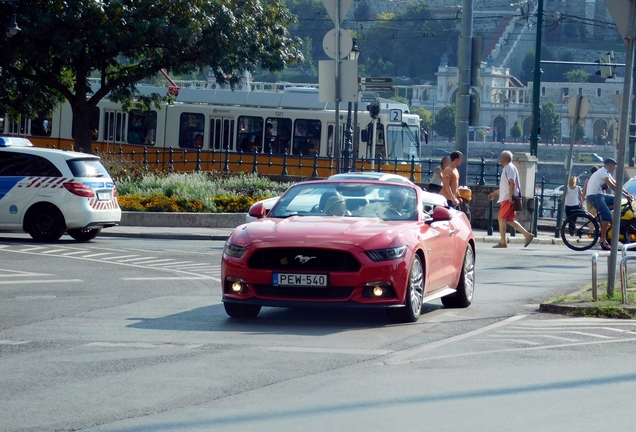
[{"xmin": 488, "ymin": 150, "xmax": 534, "ymax": 248}]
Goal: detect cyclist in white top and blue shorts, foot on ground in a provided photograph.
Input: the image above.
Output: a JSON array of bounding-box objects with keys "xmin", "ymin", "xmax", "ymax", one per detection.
[{"xmin": 585, "ymin": 158, "xmax": 632, "ymax": 250}]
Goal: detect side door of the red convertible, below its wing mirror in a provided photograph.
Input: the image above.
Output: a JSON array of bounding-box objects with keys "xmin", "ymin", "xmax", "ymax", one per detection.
[{"xmin": 421, "ymin": 221, "xmax": 457, "ymax": 294}]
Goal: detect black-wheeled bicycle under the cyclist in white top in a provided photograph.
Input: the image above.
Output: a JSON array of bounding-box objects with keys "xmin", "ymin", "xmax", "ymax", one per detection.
[{"xmin": 561, "ymin": 200, "xmax": 636, "ymax": 252}]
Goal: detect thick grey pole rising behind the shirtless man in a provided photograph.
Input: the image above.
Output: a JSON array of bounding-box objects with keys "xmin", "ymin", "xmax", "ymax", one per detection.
[{"xmin": 455, "ymin": 0, "xmax": 473, "ymax": 184}]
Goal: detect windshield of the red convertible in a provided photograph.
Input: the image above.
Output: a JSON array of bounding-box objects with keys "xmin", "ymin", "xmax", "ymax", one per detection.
[{"xmin": 269, "ymin": 182, "xmax": 417, "ymax": 221}]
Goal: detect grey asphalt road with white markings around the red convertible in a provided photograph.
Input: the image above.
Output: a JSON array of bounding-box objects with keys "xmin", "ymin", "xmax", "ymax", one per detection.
[{"xmin": 0, "ymin": 235, "xmax": 636, "ymax": 432}]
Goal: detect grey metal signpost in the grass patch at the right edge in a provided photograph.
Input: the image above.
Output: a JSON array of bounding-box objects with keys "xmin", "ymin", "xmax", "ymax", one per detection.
[{"xmin": 607, "ymin": 0, "xmax": 636, "ymax": 296}]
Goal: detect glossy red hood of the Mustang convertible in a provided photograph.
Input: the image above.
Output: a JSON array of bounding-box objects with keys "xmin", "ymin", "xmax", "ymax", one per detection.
[{"xmin": 231, "ymin": 216, "xmax": 419, "ymax": 250}]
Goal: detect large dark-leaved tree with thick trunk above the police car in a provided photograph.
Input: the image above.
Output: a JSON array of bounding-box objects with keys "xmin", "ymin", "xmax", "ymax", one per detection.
[{"xmin": 0, "ymin": 0, "xmax": 302, "ymax": 150}]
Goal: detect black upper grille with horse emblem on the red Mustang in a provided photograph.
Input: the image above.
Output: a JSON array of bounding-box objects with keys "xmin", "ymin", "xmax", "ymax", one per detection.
[{"xmin": 247, "ymin": 248, "xmax": 360, "ymax": 272}]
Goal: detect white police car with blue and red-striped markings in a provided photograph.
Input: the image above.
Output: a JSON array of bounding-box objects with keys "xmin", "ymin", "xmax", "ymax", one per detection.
[{"xmin": 0, "ymin": 137, "xmax": 121, "ymax": 242}]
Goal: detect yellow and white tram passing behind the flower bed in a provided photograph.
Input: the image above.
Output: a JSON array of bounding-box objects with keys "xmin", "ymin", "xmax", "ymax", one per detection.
[{"xmin": 0, "ymin": 86, "xmax": 428, "ymax": 176}]
